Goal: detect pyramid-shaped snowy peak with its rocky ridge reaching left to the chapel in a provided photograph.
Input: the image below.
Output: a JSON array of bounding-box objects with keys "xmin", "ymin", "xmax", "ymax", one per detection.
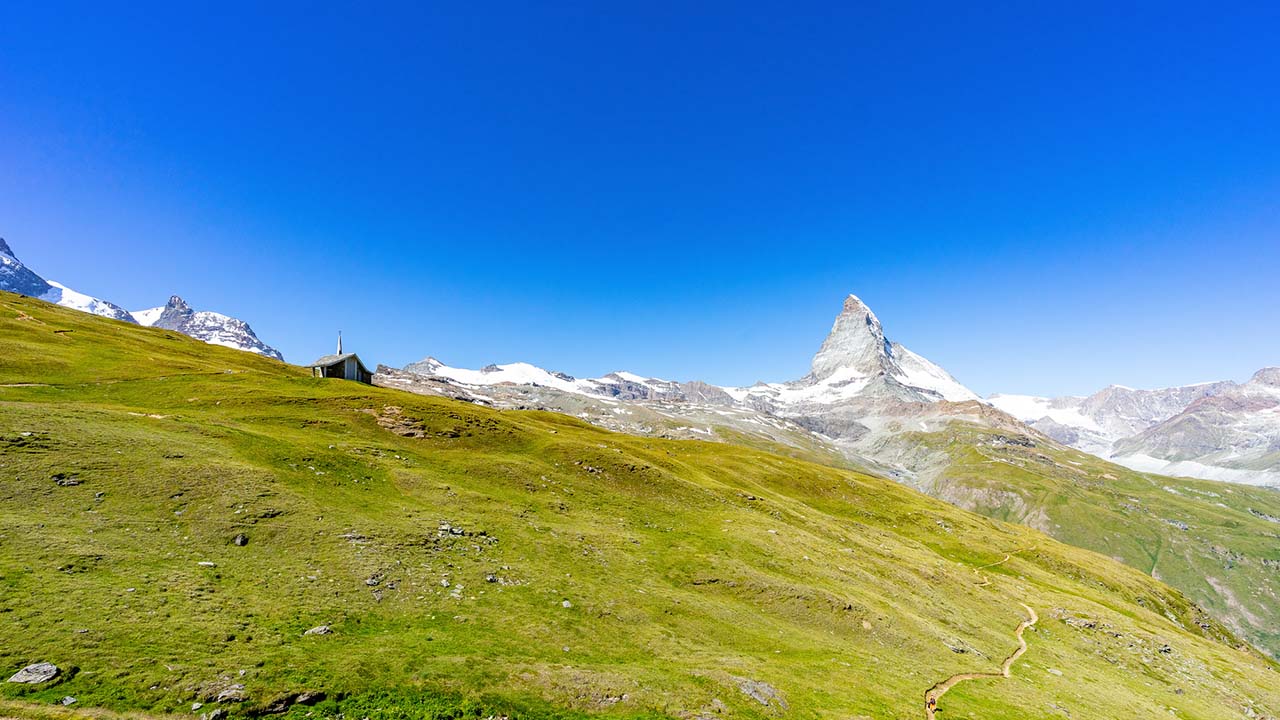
[{"xmin": 386, "ymin": 288, "xmax": 998, "ymax": 479}]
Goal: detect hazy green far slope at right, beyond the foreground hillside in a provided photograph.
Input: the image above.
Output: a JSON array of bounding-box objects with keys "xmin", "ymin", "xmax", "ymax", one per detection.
[{"xmin": 906, "ymin": 424, "xmax": 1280, "ymax": 656}]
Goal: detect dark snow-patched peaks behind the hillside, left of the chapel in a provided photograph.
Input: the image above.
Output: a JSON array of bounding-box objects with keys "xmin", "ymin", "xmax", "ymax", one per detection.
[{"xmin": 0, "ymin": 238, "xmax": 284, "ymax": 360}]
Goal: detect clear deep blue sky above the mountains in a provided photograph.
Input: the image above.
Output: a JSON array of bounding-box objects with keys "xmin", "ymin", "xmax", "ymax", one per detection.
[{"xmin": 0, "ymin": 1, "xmax": 1280, "ymax": 395}]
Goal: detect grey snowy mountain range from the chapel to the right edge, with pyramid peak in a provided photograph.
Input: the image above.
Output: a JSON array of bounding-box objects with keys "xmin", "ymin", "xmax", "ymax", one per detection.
[{"xmin": 381, "ymin": 295, "xmax": 1280, "ymax": 486}]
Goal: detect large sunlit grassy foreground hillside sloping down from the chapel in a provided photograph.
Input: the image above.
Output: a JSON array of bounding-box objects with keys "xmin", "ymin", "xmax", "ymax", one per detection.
[{"xmin": 0, "ymin": 295, "xmax": 1280, "ymax": 720}]
